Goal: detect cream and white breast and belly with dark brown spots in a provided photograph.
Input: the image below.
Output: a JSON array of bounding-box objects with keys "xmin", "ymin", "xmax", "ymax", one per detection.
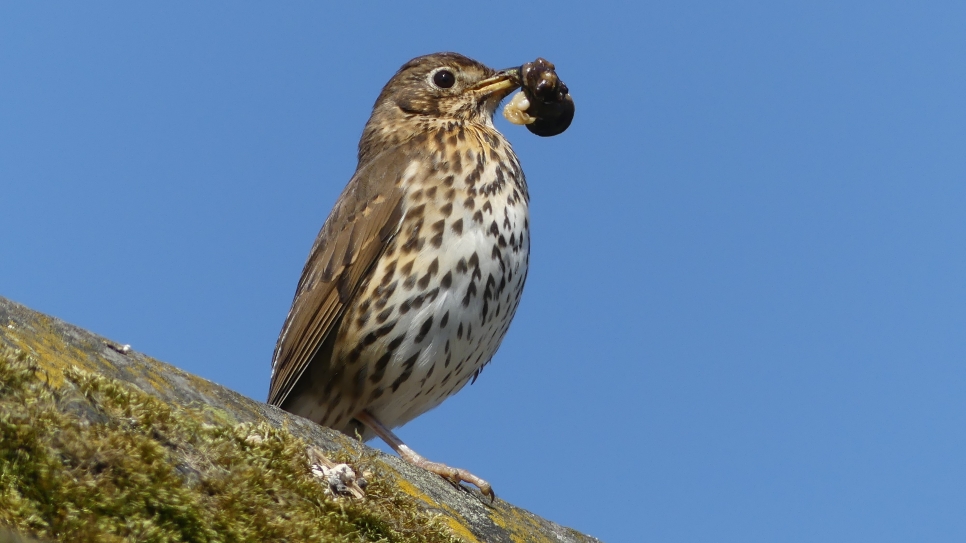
[{"xmin": 323, "ymin": 125, "xmax": 530, "ymax": 436}]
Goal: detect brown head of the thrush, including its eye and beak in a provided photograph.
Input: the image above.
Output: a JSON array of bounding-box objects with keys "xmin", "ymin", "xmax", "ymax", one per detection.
[{"xmin": 359, "ymin": 53, "xmax": 520, "ymax": 163}]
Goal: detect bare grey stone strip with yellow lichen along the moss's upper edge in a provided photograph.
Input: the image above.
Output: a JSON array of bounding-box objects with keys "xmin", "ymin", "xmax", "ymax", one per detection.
[{"xmin": 0, "ymin": 297, "xmax": 598, "ymax": 543}]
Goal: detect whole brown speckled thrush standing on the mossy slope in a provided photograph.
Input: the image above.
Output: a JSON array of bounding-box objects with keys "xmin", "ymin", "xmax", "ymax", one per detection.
[{"xmin": 268, "ymin": 52, "xmax": 530, "ymax": 500}]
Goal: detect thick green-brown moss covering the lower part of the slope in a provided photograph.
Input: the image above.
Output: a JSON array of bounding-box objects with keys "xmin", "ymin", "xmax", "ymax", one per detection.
[{"xmin": 0, "ymin": 351, "xmax": 466, "ymax": 543}]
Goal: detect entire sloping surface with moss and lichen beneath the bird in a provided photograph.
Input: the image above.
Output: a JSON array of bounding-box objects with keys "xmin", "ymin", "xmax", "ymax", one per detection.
[{"xmin": 0, "ymin": 298, "xmax": 596, "ymax": 542}]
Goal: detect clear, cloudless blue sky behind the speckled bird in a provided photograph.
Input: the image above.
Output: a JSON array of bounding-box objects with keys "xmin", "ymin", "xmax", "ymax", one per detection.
[{"xmin": 0, "ymin": 1, "xmax": 966, "ymax": 543}]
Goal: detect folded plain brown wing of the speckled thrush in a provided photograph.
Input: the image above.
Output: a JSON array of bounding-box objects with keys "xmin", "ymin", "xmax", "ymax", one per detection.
[{"xmin": 268, "ymin": 147, "xmax": 419, "ymax": 405}]
